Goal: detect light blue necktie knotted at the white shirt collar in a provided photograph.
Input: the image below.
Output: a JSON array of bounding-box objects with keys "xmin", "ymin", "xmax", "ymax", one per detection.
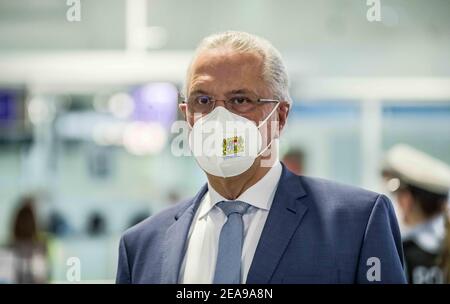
[{"xmin": 213, "ymin": 201, "xmax": 250, "ymax": 284}]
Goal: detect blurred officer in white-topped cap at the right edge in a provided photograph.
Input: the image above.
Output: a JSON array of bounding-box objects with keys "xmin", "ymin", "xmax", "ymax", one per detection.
[{"xmin": 383, "ymin": 144, "xmax": 450, "ymax": 284}]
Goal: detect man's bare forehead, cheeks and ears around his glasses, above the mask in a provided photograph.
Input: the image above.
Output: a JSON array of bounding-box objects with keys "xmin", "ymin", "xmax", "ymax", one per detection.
[{"xmin": 180, "ymin": 49, "xmax": 289, "ymax": 137}]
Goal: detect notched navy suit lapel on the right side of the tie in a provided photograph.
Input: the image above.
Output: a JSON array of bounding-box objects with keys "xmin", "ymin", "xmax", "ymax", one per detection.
[{"xmin": 247, "ymin": 165, "xmax": 308, "ymax": 284}]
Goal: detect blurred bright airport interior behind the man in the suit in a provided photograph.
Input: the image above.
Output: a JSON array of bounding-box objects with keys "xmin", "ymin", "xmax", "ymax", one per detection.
[{"xmin": 0, "ymin": 0, "xmax": 450, "ymax": 283}]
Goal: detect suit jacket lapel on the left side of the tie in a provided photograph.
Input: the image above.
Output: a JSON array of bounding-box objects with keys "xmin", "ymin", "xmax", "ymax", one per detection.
[{"xmin": 161, "ymin": 185, "xmax": 208, "ymax": 284}]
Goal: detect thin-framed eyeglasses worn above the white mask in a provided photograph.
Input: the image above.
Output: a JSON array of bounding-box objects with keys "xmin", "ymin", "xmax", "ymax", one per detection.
[{"xmin": 180, "ymin": 95, "xmax": 280, "ymax": 114}]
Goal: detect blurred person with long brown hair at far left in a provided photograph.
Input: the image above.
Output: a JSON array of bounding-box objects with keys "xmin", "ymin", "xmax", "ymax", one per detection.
[{"xmin": 10, "ymin": 196, "xmax": 49, "ymax": 284}]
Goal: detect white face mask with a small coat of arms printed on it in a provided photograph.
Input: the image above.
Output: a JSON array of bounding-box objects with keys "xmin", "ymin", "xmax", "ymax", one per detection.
[{"xmin": 189, "ymin": 104, "xmax": 278, "ymax": 177}]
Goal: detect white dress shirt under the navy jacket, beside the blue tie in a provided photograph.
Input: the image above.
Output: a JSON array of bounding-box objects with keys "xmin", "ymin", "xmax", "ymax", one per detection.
[{"xmin": 178, "ymin": 162, "xmax": 282, "ymax": 284}]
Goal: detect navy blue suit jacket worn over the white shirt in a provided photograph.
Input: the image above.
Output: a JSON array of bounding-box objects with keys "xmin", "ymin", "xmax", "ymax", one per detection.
[{"xmin": 116, "ymin": 166, "xmax": 406, "ymax": 283}]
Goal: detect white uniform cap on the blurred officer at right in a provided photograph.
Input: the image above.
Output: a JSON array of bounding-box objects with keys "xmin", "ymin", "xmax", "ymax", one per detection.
[{"xmin": 384, "ymin": 144, "xmax": 450, "ymax": 195}]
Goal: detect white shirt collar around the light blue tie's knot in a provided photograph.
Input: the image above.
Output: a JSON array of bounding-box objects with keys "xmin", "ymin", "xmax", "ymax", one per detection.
[{"xmin": 198, "ymin": 162, "xmax": 282, "ymax": 219}]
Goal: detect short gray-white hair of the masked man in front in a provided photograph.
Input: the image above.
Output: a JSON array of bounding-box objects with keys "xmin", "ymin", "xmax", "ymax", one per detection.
[{"xmin": 183, "ymin": 31, "xmax": 292, "ymax": 103}]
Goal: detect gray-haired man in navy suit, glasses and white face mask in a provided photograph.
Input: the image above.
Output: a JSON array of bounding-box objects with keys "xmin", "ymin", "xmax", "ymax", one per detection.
[{"xmin": 116, "ymin": 32, "xmax": 405, "ymax": 284}]
